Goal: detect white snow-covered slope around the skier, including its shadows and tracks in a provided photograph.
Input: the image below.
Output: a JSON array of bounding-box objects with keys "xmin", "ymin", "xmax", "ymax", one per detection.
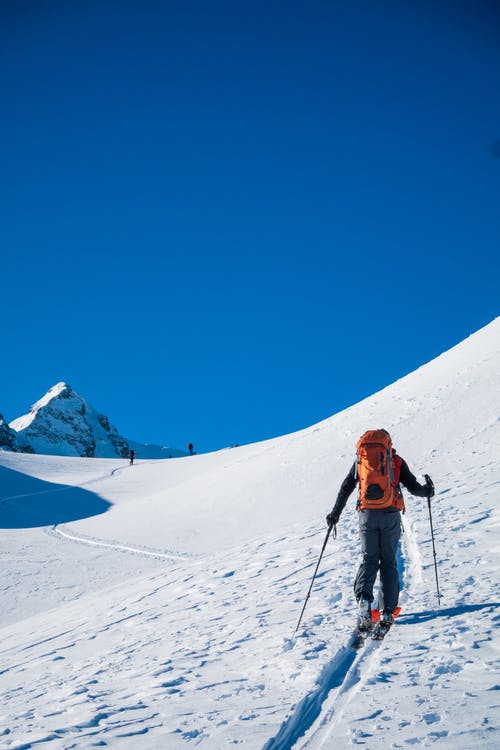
[{"xmin": 0, "ymin": 319, "xmax": 500, "ymax": 750}]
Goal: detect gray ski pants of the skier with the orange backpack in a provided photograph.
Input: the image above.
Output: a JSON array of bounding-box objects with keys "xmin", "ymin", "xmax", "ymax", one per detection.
[{"xmin": 354, "ymin": 510, "xmax": 401, "ymax": 612}]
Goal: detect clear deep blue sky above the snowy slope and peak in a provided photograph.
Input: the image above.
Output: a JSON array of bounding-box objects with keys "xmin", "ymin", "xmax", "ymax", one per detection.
[{"xmin": 0, "ymin": 0, "xmax": 500, "ymax": 451}]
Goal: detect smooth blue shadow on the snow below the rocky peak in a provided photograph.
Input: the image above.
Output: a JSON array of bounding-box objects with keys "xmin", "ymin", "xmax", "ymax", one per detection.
[{"xmin": 0, "ymin": 466, "xmax": 111, "ymax": 529}]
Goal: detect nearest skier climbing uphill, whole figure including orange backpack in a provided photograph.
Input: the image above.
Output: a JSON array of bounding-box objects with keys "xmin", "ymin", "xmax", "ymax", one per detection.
[{"xmin": 326, "ymin": 430, "xmax": 434, "ymax": 632}]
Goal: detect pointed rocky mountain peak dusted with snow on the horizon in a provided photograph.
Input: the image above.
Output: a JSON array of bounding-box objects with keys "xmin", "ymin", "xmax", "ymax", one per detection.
[{"xmin": 5, "ymin": 382, "xmax": 185, "ymax": 458}]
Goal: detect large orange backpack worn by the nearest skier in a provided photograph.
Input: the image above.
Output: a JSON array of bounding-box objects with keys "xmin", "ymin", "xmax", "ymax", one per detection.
[{"xmin": 356, "ymin": 430, "xmax": 404, "ymax": 510}]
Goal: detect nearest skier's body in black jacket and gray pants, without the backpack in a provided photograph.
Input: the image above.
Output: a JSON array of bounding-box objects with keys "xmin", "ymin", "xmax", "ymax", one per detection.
[{"xmin": 326, "ymin": 450, "xmax": 434, "ymax": 628}]
